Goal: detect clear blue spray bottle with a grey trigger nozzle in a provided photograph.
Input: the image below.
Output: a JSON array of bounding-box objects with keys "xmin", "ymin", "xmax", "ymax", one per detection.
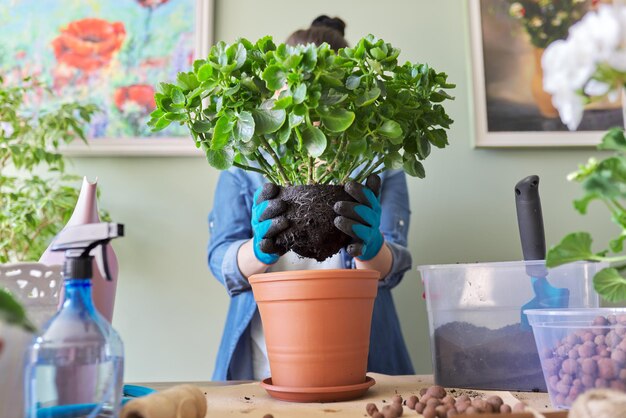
[{"xmin": 25, "ymin": 223, "xmax": 124, "ymax": 418}]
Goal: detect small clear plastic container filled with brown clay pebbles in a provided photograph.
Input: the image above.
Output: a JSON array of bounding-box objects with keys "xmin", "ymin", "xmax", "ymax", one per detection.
[{"xmin": 526, "ymin": 308, "xmax": 626, "ymax": 408}]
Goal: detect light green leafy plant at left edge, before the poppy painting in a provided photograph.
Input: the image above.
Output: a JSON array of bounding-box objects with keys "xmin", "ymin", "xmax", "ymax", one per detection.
[{"xmin": 0, "ymin": 77, "xmax": 97, "ymax": 263}]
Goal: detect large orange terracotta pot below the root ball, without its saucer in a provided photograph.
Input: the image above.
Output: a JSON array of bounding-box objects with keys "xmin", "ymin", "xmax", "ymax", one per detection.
[{"xmin": 249, "ymin": 270, "xmax": 380, "ymax": 388}]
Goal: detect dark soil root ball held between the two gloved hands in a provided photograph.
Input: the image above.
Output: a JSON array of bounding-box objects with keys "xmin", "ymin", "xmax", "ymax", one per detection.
[{"xmin": 276, "ymin": 185, "xmax": 354, "ymax": 261}]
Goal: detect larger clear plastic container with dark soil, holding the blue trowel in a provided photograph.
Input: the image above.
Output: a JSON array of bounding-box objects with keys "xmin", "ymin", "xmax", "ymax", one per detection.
[{"xmin": 418, "ymin": 260, "xmax": 606, "ymax": 392}]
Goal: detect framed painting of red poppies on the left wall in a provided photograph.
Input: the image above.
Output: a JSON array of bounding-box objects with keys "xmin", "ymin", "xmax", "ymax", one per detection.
[{"xmin": 0, "ymin": 0, "xmax": 213, "ymax": 155}]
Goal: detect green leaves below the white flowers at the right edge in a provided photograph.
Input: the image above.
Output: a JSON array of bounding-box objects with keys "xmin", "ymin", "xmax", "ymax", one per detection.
[{"xmin": 546, "ymin": 128, "xmax": 626, "ymax": 302}]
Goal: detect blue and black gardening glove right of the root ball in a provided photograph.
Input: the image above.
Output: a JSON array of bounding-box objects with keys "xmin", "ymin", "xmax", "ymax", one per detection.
[{"xmin": 334, "ymin": 174, "xmax": 385, "ymax": 261}]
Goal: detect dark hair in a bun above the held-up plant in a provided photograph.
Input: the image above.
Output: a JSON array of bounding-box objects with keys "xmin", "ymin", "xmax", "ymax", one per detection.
[{"xmin": 285, "ymin": 15, "xmax": 348, "ymax": 51}]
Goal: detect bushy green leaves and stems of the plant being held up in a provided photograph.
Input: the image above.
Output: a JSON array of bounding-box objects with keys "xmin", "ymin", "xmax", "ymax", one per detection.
[{"xmin": 149, "ymin": 35, "xmax": 454, "ymax": 185}]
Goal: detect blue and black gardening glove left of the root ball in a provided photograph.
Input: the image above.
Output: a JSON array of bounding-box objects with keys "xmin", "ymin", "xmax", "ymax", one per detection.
[{"xmin": 251, "ymin": 183, "xmax": 289, "ymax": 264}]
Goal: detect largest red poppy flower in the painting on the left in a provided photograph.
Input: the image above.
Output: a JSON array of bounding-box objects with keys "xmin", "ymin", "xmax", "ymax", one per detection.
[{"xmin": 52, "ymin": 18, "xmax": 126, "ymax": 71}]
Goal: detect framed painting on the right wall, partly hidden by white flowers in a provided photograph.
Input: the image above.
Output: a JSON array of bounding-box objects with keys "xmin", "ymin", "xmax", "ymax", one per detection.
[{"xmin": 469, "ymin": 0, "xmax": 623, "ymax": 147}]
